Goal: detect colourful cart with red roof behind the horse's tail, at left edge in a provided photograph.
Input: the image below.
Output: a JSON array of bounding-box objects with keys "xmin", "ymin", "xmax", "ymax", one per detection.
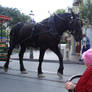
[{"xmin": 0, "ymin": 15, "xmax": 11, "ymax": 61}]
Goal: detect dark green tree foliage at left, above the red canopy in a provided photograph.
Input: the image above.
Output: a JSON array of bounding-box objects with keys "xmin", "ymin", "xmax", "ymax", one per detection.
[{"xmin": 0, "ymin": 6, "xmax": 30, "ymax": 26}]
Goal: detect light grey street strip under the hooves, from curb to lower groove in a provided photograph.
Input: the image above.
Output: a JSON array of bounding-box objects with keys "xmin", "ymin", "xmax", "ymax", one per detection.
[{"xmin": 0, "ymin": 60, "xmax": 85, "ymax": 83}]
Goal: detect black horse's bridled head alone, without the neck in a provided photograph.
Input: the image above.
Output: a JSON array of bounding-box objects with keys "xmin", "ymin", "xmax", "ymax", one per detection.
[{"xmin": 68, "ymin": 12, "xmax": 83, "ymax": 41}]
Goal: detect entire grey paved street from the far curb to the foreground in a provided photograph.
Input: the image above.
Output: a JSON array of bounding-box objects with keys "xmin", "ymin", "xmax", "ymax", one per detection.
[{"xmin": 0, "ymin": 57, "xmax": 85, "ymax": 92}]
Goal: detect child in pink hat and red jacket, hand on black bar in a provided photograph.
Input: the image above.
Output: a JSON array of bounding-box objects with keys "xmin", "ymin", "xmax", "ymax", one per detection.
[{"xmin": 65, "ymin": 49, "xmax": 92, "ymax": 92}]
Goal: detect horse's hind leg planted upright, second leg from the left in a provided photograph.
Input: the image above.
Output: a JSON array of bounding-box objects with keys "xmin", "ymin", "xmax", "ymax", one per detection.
[{"xmin": 19, "ymin": 47, "xmax": 27, "ymax": 74}]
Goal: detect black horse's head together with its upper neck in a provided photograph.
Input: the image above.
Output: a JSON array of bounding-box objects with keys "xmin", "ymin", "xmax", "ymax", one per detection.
[{"xmin": 55, "ymin": 12, "xmax": 83, "ymax": 41}]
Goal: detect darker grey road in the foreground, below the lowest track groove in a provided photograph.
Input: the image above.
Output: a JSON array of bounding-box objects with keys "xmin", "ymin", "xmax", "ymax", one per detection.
[{"xmin": 0, "ymin": 74, "xmax": 67, "ymax": 92}]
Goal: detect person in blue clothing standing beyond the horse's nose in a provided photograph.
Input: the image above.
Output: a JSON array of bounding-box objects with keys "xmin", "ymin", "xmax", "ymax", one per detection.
[{"xmin": 79, "ymin": 34, "xmax": 90, "ymax": 61}]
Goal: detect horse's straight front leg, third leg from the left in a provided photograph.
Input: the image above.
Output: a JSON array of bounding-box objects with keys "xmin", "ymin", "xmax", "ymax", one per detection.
[{"xmin": 38, "ymin": 49, "xmax": 46, "ymax": 77}]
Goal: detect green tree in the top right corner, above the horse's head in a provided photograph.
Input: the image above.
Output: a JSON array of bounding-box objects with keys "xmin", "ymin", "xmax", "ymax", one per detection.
[{"xmin": 80, "ymin": 0, "xmax": 92, "ymax": 25}]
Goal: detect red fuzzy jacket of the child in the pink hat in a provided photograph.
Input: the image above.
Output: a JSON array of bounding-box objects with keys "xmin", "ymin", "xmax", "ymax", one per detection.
[{"xmin": 75, "ymin": 66, "xmax": 92, "ymax": 92}]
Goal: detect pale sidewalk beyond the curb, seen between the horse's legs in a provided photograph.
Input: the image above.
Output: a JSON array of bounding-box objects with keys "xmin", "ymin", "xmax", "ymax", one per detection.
[{"xmin": 11, "ymin": 50, "xmax": 84, "ymax": 64}]
